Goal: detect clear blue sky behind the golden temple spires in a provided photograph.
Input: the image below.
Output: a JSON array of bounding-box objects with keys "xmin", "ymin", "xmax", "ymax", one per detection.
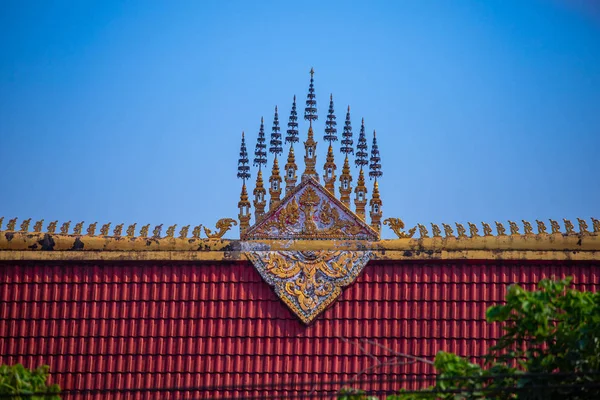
[{"xmin": 0, "ymin": 0, "xmax": 600, "ymax": 237}]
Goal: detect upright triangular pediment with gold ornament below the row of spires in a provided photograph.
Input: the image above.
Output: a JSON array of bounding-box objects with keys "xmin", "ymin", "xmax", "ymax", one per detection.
[{"xmin": 242, "ymin": 178, "xmax": 379, "ymax": 240}]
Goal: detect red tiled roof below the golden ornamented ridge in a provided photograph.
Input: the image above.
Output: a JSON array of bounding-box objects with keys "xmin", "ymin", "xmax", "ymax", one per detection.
[{"xmin": 0, "ymin": 261, "xmax": 600, "ymax": 399}]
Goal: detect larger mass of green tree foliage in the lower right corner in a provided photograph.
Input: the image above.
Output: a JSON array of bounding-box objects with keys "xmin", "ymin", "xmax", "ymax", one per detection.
[{"xmin": 340, "ymin": 278, "xmax": 600, "ymax": 400}]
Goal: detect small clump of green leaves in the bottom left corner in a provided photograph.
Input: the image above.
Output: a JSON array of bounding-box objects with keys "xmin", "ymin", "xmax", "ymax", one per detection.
[{"xmin": 0, "ymin": 364, "xmax": 60, "ymax": 400}]
